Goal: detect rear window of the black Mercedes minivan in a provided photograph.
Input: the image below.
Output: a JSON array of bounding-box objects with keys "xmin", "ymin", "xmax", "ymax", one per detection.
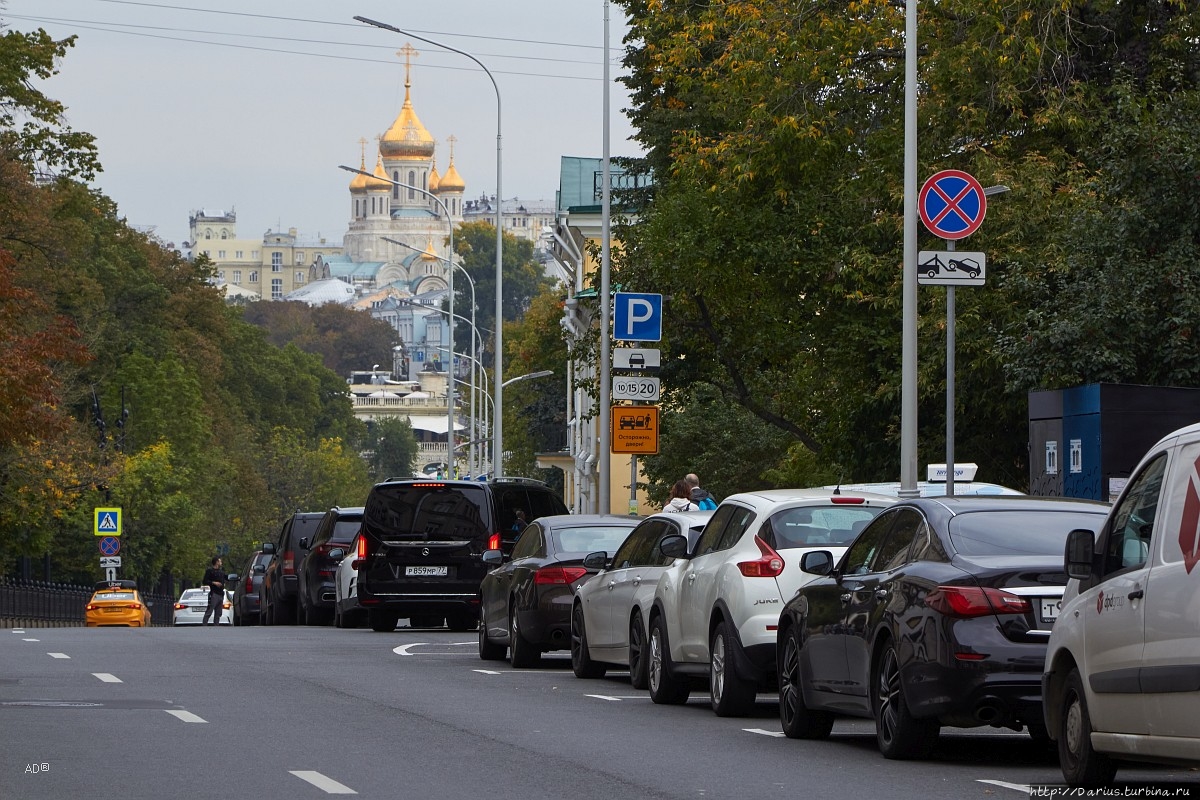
[{"xmin": 362, "ymin": 482, "xmax": 488, "ymax": 541}]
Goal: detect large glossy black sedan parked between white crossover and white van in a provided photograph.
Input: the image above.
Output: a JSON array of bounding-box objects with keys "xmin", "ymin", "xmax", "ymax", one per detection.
[{"xmin": 776, "ymin": 495, "xmax": 1108, "ymax": 758}]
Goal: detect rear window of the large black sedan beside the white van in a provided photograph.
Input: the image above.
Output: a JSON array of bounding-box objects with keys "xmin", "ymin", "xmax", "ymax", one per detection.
[{"xmin": 949, "ymin": 511, "xmax": 1105, "ymax": 559}]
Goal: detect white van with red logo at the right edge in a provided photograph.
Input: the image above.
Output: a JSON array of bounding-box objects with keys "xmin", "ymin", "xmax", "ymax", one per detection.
[{"xmin": 1043, "ymin": 425, "xmax": 1200, "ymax": 787}]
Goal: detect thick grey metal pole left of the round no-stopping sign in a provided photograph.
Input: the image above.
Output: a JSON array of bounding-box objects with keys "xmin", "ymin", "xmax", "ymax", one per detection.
[{"xmin": 900, "ymin": 0, "xmax": 917, "ymax": 498}]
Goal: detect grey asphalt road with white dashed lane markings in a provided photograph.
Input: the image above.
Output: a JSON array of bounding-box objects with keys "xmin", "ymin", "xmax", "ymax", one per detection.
[{"xmin": 0, "ymin": 627, "xmax": 1200, "ymax": 800}]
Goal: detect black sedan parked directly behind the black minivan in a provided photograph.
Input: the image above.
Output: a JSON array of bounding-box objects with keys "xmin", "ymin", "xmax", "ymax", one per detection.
[{"xmin": 479, "ymin": 515, "xmax": 641, "ymax": 667}]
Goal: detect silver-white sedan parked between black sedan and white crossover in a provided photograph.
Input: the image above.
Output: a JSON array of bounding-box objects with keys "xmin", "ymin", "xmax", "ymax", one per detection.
[{"xmin": 571, "ymin": 511, "xmax": 713, "ymax": 688}]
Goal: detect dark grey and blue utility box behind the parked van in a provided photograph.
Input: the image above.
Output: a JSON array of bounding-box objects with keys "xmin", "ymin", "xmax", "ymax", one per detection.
[{"xmin": 1030, "ymin": 384, "xmax": 1200, "ymax": 503}]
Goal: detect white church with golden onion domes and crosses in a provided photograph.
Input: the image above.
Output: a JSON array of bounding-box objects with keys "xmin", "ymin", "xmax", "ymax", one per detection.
[{"xmin": 329, "ymin": 44, "xmax": 467, "ymax": 295}]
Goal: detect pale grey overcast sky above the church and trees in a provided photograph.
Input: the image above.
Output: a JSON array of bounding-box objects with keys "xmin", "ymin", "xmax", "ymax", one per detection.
[{"xmin": 0, "ymin": 0, "xmax": 638, "ymax": 246}]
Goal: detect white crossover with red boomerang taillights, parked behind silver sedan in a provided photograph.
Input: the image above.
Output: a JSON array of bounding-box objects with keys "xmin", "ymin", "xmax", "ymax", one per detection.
[{"xmin": 648, "ymin": 488, "xmax": 896, "ymax": 716}]
